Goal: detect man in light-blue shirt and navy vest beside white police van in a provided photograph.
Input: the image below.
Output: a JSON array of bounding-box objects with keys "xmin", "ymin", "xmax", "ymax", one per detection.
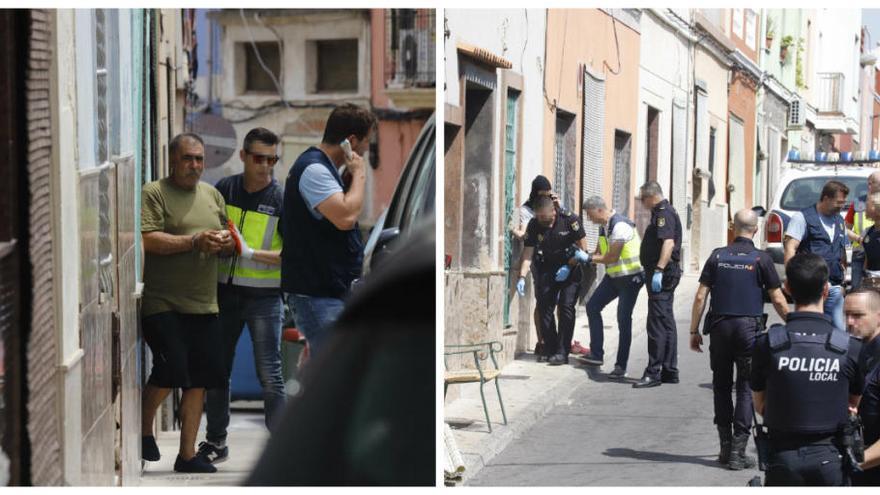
[{"xmin": 785, "ymin": 180, "xmax": 849, "ymax": 330}]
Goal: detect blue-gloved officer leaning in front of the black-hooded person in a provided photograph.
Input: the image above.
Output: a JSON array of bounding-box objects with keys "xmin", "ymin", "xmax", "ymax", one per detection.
[{"xmin": 516, "ymin": 196, "xmax": 589, "ymax": 365}]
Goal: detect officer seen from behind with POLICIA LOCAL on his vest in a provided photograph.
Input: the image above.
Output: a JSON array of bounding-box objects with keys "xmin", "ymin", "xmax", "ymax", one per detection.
[{"xmin": 751, "ymin": 253, "xmax": 864, "ymax": 486}]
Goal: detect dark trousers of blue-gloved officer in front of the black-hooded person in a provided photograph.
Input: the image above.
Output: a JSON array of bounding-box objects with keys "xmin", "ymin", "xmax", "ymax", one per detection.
[{"xmin": 537, "ymin": 267, "xmax": 581, "ymax": 357}]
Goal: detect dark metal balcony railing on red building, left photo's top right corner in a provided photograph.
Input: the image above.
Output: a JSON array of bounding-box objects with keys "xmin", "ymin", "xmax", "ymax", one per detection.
[{"xmin": 385, "ymin": 9, "xmax": 436, "ymax": 88}]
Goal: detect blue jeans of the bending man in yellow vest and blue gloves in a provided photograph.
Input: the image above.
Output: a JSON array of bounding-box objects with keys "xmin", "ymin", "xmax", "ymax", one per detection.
[{"xmin": 587, "ymin": 273, "xmax": 645, "ymax": 370}]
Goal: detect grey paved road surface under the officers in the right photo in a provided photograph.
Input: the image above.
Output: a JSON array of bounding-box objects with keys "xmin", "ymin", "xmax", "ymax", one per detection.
[{"xmin": 469, "ymin": 286, "xmax": 770, "ymax": 486}]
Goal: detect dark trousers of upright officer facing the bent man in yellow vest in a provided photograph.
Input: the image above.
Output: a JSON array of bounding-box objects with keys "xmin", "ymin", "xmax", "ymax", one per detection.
[{"xmin": 644, "ymin": 272, "xmax": 681, "ymax": 380}]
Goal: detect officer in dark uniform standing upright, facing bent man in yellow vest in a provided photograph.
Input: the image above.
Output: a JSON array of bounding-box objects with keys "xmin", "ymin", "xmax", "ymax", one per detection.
[{"xmin": 633, "ymin": 181, "xmax": 681, "ymax": 388}]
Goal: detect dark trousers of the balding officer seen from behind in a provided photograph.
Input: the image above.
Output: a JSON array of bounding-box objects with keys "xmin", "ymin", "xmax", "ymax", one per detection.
[{"xmin": 706, "ymin": 317, "xmax": 758, "ymax": 434}]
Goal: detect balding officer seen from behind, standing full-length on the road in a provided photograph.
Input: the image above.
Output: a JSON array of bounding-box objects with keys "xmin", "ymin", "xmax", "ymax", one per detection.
[{"xmin": 691, "ymin": 210, "xmax": 788, "ymax": 470}]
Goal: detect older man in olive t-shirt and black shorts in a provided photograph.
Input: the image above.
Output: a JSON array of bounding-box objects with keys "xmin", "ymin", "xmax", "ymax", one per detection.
[{"xmin": 141, "ymin": 134, "xmax": 235, "ymax": 473}]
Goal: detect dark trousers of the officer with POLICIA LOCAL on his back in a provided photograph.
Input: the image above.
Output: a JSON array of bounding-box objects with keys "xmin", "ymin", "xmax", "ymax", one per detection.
[{"xmin": 764, "ymin": 444, "xmax": 850, "ymax": 486}]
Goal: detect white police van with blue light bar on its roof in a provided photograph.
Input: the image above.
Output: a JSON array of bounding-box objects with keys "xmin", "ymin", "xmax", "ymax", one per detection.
[{"xmin": 758, "ymin": 150, "xmax": 880, "ymax": 282}]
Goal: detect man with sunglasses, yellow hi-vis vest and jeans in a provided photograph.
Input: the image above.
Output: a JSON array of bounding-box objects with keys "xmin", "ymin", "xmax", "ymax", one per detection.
[{"xmin": 199, "ymin": 127, "xmax": 284, "ymax": 463}]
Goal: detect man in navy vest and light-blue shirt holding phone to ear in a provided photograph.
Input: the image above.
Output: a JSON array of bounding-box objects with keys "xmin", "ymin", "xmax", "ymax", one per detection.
[{"xmin": 281, "ymin": 103, "xmax": 376, "ymax": 357}]
